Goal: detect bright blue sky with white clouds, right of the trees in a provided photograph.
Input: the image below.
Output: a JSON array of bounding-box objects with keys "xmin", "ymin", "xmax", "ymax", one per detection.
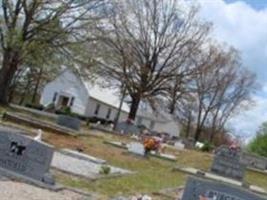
[{"xmin": 196, "ymin": 0, "xmax": 267, "ymax": 141}]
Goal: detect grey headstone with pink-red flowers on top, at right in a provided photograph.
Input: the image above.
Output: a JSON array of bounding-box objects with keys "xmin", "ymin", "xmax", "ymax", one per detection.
[{"xmin": 210, "ymin": 146, "xmax": 245, "ymax": 181}]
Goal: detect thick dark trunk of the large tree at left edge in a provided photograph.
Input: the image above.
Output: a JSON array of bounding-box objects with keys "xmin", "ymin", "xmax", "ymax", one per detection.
[{"xmin": 0, "ymin": 52, "xmax": 19, "ymax": 105}]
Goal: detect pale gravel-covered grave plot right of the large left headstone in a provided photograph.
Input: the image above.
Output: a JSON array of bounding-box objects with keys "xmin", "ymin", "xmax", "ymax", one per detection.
[{"xmin": 51, "ymin": 152, "xmax": 131, "ymax": 179}]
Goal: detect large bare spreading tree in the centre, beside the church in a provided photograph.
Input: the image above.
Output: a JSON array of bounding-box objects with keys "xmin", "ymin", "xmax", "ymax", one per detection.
[{"xmin": 96, "ymin": 0, "xmax": 210, "ymax": 119}]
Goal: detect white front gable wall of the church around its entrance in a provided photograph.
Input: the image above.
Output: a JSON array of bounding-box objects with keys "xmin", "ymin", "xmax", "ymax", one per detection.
[{"xmin": 40, "ymin": 70, "xmax": 88, "ymax": 115}]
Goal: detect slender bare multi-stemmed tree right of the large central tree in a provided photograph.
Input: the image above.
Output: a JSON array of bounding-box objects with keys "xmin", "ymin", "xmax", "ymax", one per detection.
[{"xmin": 194, "ymin": 45, "xmax": 255, "ymax": 141}]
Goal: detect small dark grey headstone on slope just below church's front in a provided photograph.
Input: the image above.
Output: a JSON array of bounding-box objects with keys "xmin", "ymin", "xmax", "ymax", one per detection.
[{"xmin": 57, "ymin": 115, "xmax": 81, "ymax": 131}]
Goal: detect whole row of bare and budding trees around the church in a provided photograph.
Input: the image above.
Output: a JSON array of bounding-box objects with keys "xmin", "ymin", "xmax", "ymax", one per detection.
[{"xmin": 0, "ymin": 0, "xmax": 255, "ymax": 144}]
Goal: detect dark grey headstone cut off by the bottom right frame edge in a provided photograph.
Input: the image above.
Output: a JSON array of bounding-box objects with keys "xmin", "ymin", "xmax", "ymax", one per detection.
[{"xmin": 182, "ymin": 177, "xmax": 267, "ymax": 200}]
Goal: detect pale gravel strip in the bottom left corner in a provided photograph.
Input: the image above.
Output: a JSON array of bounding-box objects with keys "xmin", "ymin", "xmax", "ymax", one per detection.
[{"xmin": 0, "ymin": 181, "xmax": 90, "ymax": 200}]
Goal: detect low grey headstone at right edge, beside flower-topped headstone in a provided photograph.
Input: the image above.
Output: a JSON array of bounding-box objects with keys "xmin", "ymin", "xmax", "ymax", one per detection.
[{"xmin": 241, "ymin": 152, "xmax": 267, "ymax": 170}]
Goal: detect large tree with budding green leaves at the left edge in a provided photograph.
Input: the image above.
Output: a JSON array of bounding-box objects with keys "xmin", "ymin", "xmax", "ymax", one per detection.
[{"xmin": 0, "ymin": 0, "xmax": 102, "ymax": 104}]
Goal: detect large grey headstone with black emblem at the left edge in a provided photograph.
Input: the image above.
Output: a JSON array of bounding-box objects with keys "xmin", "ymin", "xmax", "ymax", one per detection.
[{"xmin": 0, "ymin": 127, "xmax": 54, "ymax": 185}]
